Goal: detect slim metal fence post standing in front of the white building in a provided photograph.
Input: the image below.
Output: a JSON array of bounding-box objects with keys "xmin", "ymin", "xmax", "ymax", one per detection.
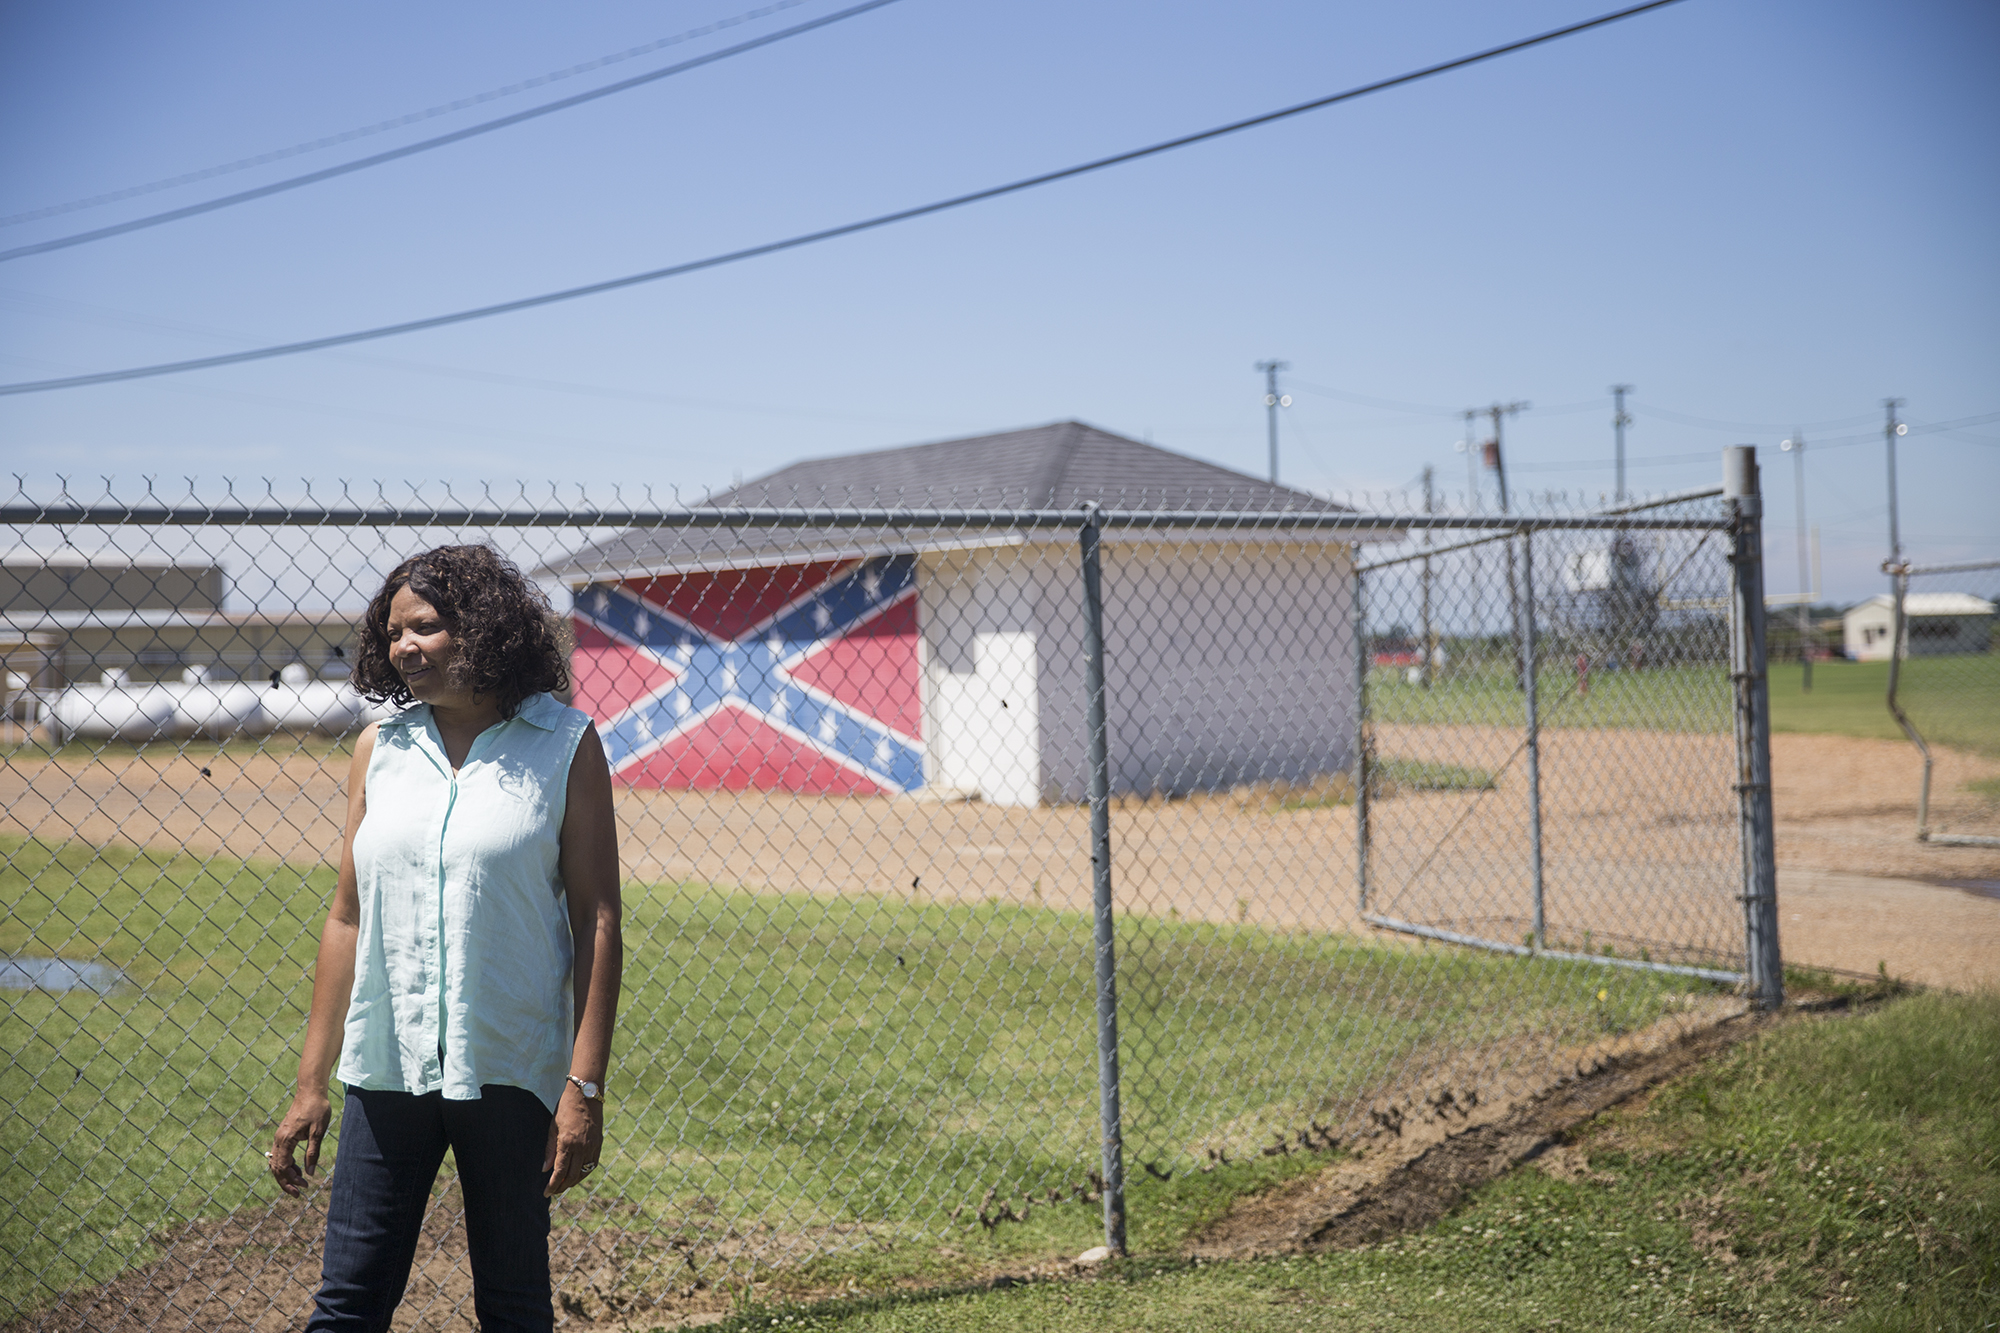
[{"xmin": 1076, "ymin": 504, "xmax": 1126, "ymax": 1255}]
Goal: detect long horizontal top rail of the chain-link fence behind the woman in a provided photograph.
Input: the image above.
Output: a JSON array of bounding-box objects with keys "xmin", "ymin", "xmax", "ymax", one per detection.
[{"xmin": 0, "ymin": 504, "xmax": 1730, "ymax": 534}]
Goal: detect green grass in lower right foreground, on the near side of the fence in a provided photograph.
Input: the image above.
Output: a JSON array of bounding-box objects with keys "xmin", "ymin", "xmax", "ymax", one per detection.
[{"xmin": 704, "ymin": 993, "xmax": 2000, "ymax": 1333}]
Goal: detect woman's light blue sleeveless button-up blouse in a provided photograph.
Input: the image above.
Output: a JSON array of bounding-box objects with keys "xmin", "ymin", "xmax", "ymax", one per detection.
[{"xmin": 338, "ymin": 695, "xmax": 590, "ymax": 1113}]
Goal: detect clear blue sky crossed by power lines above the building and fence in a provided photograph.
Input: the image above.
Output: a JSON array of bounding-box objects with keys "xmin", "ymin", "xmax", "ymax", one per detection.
[{"xmin": 0, "ymin": 0, "xmax": 2000, "ymax": 598}]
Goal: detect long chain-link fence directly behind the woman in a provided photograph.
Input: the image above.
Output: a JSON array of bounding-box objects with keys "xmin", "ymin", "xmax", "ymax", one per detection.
[{"xmin": 0, "ymin": 454, "xmax": 1776, "ymax": 1329}]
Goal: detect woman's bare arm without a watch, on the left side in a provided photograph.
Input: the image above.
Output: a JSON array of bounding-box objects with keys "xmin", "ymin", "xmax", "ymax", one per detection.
[{"xmin": 270, "ymin": 725, "xmax": 376, "ymax": 1195}]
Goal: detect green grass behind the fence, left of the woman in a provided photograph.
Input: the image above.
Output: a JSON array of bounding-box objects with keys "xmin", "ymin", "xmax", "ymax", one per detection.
[{"xmin": 0, "ymin": 839, "xmax": 332, "ymax": 1311}]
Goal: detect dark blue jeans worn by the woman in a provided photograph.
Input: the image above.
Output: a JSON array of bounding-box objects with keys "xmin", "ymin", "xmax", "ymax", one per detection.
[{"xmin": 306, "ymin": 1085, "xmax": 556, "ymax": 1333}]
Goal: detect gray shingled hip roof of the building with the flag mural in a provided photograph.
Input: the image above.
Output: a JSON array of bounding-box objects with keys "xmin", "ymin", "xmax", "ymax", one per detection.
[{"xmin": 536, "ymin": 420, "xmax": 1354, "ymax": 582}]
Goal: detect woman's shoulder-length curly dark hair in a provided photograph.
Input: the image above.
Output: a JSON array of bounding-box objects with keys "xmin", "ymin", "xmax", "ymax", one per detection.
[{"xmin": 352, "ymin": 546, "xmax": 570, "ymax": 717}]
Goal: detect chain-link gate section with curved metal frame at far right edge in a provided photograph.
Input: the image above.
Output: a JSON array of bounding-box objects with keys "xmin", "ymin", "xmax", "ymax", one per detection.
[{"xmin": 1880, "ymin": 560, "xmax": 2000, "ymax": 847}]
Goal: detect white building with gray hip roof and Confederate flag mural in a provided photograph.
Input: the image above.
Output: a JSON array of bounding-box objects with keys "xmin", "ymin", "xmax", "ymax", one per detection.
[{"xmin": 538, "ymin": 422, "xmax": 1400, "ymax": 805}]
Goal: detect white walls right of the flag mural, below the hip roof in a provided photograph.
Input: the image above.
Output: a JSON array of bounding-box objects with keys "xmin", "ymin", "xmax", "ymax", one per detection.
[{"xmin": 918, "ymin": 538, "xmax": 1354, "ymax": 805}]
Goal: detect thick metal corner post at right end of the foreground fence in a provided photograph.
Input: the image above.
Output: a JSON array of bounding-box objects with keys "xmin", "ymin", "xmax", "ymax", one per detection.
[{"xmin": 1722, "ymin": 444, "xmax": 1784, "ymax": 1009}]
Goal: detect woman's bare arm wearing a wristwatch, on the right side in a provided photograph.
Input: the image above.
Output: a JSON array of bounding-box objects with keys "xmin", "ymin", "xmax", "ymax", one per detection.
[{"xmin": 542, "ymin": 729, "xmax": 624, "ymax": 1195}]
